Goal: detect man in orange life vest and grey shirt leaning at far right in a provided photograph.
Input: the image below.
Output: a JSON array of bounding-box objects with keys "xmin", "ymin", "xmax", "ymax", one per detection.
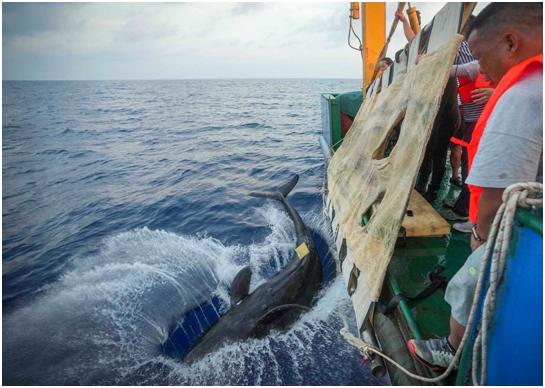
[{"xmin": 408, "ymin": 3, "xmax": 543, "ymax": 369}]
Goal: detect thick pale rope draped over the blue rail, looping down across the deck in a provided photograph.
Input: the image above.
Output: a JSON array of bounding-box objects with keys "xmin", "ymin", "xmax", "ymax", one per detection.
[{"xmin": 341, "ymin": 182, "xmax": 543, "ymax": 385}]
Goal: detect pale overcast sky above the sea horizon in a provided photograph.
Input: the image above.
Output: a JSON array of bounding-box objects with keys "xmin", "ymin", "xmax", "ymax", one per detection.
[{"xmin": 2, "ymin": 2, "xmax": 484, "ymax": 80}]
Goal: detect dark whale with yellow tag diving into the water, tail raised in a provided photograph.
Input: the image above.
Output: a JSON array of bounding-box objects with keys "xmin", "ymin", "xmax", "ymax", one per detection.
[{"xmin": 185, "ymin": 175, "xmax": 322, "ymax": 362}]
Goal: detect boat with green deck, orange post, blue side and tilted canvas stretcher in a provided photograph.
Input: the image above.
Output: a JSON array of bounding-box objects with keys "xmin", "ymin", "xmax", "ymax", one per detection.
[{"xmin": 320, "ymin": 3, "xmax": 543, "ymax": 385}]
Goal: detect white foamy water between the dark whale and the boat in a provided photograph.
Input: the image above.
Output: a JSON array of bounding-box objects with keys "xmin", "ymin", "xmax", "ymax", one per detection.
[{"xmin": 155, "ymin": 278, "xmax": 364, "ymax": 385}]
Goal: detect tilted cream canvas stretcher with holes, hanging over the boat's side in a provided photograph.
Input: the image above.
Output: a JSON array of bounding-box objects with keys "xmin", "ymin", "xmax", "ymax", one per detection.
[{"xmin": 326, "ymin": 31, "xmax": 462, "ymax": 328}]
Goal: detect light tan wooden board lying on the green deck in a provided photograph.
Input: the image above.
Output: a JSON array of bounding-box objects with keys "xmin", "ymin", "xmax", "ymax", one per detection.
[{"xmin": 401, "ymin": 190, "xmax": 450, "ymax": 237}]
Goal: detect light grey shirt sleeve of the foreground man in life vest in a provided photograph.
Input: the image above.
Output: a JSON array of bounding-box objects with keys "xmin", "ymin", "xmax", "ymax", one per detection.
[{"xmin": 467, "ymin": 70, "xmax": 543, "ymax": 188}]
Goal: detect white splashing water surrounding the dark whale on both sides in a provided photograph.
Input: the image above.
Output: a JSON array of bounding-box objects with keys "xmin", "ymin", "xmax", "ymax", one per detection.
[{"xmin": 3, "ymin": 204, "xmax": 384, "ymax": 385}]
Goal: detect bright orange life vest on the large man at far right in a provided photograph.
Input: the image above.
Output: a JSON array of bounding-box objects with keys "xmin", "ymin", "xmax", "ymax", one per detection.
[{"xmin": 467, "ymin": 53, "xmax": 543, "ymax": 223}]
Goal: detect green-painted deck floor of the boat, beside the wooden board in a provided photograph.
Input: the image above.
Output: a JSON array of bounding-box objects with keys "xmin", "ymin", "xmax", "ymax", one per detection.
[{"xmin": 376, "ymin": 177, "xmax": 471, "ymax": 385}]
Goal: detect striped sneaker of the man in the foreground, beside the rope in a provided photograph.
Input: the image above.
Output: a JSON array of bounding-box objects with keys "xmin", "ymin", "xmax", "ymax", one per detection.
[{"xmin": 407, "ymin": 337, "xmax": 456, "ymax": 371}]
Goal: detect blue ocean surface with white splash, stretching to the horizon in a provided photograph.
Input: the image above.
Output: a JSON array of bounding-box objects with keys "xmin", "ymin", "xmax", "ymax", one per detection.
[{"xmin": 2, "ymin": 80, "xmax": 385, "ymax": 385}]
